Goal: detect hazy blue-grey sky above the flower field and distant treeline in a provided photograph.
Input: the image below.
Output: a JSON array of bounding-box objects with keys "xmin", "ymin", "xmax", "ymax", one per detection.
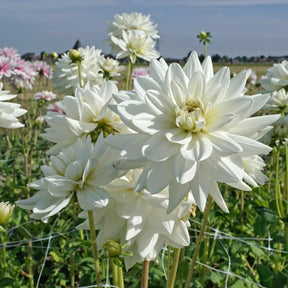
[{"xmin": 0, "ymin": 0, "xmax": 288, "ymax": 59}]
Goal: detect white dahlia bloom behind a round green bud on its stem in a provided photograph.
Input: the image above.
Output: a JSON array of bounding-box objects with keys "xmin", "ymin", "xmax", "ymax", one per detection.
[{"xmin": 53, "ymin": 46, "xmax": 104, "ymax": 95}]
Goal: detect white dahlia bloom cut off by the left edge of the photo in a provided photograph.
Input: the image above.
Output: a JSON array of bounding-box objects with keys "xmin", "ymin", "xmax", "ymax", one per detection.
[{"xmin": 0, "ymin": 82, "xmax": 27, "ymax": 128}]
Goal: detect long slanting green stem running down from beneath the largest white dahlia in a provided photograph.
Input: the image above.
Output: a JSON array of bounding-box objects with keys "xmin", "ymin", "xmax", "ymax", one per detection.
[{"xmin": 185, "ymin": 196, "xmax": 213, "ymax": 288}]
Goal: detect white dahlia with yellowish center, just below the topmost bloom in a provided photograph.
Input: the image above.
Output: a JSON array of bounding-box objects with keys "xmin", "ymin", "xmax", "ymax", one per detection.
[{"xmin": 111, "ymin": 30, "xmax": 160, "ymax": 64}]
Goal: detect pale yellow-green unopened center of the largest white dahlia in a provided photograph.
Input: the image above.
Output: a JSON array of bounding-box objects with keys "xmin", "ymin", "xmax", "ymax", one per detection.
[{"xmin": 175, "ymin": 100, "xmax": 206, "ymax": 132}]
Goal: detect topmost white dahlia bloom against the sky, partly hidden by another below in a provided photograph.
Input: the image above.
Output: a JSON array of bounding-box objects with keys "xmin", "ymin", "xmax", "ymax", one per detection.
[{"xmin": 107, "ymin": 12, "xmax": 159, "ymax": 39}]
